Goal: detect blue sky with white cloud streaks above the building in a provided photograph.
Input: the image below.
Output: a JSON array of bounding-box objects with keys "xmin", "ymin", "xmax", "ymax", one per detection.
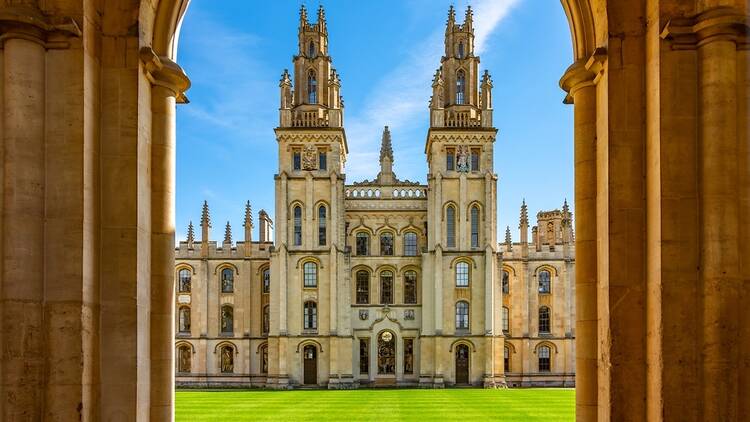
[{"xmin": 176, "ymin": 0, "xmax": 574, "ymax": 241}]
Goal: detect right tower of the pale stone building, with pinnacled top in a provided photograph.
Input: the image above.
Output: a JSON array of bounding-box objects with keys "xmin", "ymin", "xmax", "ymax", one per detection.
[{"xmin": 421, "ymin": 7, "xmax": 503, "ymax": 385}]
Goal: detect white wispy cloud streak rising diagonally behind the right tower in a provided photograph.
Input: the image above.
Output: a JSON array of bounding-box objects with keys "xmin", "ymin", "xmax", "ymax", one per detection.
[{"xmin": 346, "ymin": 0, "xmax": 521, "ymax": 180}]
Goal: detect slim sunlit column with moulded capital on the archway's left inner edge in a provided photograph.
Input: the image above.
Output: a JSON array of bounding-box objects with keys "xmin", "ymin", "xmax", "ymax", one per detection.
[{"xmin": 141, "ymin": 47, "xmax": 190, "ymax": 421}]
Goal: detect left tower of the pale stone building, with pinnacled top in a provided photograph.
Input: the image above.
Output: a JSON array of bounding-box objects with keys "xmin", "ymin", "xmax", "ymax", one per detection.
[{"xmin": 268, "ymin": 6, "xmax": 352, "ymax": 388}]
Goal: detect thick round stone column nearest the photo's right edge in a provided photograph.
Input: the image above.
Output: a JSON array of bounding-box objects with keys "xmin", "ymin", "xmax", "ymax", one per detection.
[{"xmin": 695, "ymin": 10, "xmax": 747, "ymax": 420}]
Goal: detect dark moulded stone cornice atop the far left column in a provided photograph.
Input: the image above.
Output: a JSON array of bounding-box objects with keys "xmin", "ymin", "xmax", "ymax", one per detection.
[{"xmin": 0, "ymin": 6, "xmax": 83, "ymax": 49}]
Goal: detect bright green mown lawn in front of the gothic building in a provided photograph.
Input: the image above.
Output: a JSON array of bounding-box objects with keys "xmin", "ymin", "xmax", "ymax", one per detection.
[{"xmin": 175, "ymin": 388, "xmax": 575, "ymax": 422}]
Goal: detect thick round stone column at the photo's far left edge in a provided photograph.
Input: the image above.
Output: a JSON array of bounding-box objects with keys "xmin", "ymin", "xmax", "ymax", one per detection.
[{"xmin": 0, "ymin": 28, "xmax": 46, "ymax": 420}]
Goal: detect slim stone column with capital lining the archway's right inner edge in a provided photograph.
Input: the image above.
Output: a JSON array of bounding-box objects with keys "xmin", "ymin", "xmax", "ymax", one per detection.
[{"xmin": 560, "ymin": 61, "xmax": 597, "ymax": 421}]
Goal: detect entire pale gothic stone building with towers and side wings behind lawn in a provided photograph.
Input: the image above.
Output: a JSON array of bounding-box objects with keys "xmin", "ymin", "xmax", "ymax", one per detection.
[{"xmin": 175, "ymin": 8, "xmax": 575, "ymax": 388}]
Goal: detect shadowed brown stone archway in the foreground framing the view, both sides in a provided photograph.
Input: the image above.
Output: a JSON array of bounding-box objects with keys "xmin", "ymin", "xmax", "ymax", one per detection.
[{"xmin": 0, "ymin": 0, "xmax": 750, "ymax": 421}]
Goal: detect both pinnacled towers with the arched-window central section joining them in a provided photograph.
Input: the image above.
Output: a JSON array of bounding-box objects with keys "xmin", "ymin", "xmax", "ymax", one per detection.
[{"xmin": 267, "ymin": 7, "xmax": 505, "ymax": 388}]
